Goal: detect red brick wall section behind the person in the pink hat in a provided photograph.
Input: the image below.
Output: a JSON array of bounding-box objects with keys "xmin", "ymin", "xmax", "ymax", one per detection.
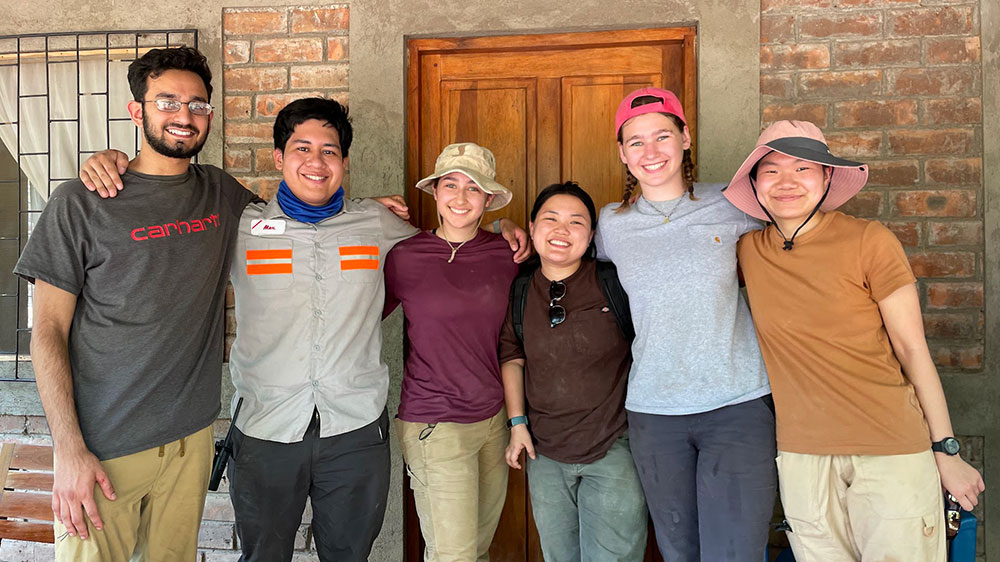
[{"xmin": 760, "ymin": 0, "xmax": 992, "ymax": 556}]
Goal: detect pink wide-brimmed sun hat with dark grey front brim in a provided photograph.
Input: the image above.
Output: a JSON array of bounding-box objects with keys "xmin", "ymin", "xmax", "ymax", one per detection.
[{"xmin": 723, "ymin": 121, "xmax": 868, "ymax": 221}]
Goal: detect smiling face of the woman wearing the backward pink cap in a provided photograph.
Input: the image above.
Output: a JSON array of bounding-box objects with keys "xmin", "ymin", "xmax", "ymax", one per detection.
[{"xmin": 618, "ymin": 113, "xmax": 691, "ymax": 195}]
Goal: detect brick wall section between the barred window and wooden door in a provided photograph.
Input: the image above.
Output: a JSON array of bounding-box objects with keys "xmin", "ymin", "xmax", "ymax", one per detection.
[{"xmin": 222, "ymin": 4, "xmax": 350, "ymax": 199}]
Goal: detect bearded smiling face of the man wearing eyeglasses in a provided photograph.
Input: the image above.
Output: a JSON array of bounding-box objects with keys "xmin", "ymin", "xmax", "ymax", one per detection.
[{"xmin": 129, "ymin": 70, "xmax": 212, "ymax": 159}]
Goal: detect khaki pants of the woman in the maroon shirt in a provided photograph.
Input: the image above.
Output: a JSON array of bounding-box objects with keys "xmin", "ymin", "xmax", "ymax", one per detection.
[{"xmin": 396, "ymin": 408, "xmax": 510, "ymax": 562}]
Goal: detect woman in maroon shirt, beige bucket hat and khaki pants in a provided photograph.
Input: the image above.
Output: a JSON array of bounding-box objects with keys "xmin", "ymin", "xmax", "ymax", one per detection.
[{"xmin": 385, "ymin": 143, "xmax": 517, "ymax": 562}]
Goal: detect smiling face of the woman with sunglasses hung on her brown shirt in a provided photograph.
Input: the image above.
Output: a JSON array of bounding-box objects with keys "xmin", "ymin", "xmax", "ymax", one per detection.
[{"xmin": 528, "ymin": 193, "xmax": 594, "ymax": 268}]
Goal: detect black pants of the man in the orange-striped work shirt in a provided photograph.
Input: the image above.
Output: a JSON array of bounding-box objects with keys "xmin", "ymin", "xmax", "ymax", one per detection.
[{"xmin": 228, "ymin": 410, "xmax": 390, "ymax": 562}]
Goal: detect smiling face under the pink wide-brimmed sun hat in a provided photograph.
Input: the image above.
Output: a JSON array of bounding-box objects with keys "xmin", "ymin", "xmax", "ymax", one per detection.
[{"xmin": 756, "ymin": 152, "xmax": 831, "ymax": 227}]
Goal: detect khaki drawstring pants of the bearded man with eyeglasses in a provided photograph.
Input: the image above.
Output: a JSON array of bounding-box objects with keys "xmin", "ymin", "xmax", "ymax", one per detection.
[{"xmin": 55, "ymin": 426, "xmax": 214, "ymax": 562}]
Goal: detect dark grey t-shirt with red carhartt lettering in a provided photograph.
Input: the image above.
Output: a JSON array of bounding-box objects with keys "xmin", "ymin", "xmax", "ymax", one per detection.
[{"xmin": 14, "ymin": 165, "xmax": 254, "ymax": 460}]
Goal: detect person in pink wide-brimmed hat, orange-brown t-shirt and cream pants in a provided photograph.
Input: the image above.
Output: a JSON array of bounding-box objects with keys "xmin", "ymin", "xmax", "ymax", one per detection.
[{"xmin": 725, "ymin": 121, "xmax": 984, "ymax": 562}]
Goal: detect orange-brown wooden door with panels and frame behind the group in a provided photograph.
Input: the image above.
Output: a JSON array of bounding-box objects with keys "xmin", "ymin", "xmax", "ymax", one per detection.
[{"xmin": 404, "ymin": 27, "xmax": 698, "ymax": 562}]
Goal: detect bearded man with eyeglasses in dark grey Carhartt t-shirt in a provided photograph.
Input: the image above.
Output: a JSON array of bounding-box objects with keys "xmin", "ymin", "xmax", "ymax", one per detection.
[{"xmin": 14, "ymin": 47, "xmax": 255, "ymax": 562}]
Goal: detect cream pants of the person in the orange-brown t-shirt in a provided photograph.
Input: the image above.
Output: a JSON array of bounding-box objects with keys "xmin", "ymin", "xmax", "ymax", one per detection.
[{"xmin": 777, "ymin": 450, "xmax": 946, "ymax": 562}]
